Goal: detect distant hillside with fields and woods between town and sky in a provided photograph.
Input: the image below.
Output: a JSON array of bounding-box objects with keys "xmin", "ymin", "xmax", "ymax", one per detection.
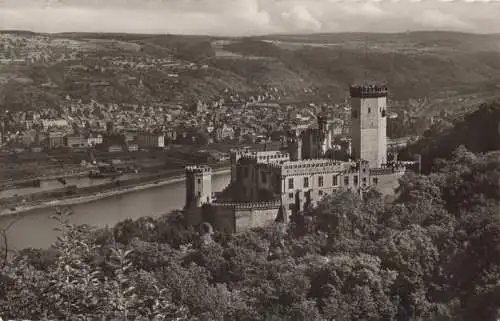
[{"xmin": 0, "ymin": 32, "xmax": 500, "ymax": 109}]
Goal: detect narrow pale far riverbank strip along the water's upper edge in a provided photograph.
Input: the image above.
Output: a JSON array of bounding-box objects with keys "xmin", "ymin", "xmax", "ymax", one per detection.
[{"xmin": 0, "ymin": 168, "xmax": 230, "ymax": 216}]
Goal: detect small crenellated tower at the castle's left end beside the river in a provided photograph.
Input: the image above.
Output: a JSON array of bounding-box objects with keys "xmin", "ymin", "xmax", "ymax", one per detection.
[{"xmin": 185, "ymin": 165, "xmax": 212, "ymax": 208}]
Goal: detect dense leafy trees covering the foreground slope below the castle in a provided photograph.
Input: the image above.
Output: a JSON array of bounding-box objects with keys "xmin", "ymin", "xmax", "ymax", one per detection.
[{"xmin": 0, "ymin": 148, "xmax": 500, "ymax": 321}]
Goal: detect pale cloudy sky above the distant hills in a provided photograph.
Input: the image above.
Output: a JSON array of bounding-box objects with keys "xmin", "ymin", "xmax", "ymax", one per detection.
[{"xmin": 0, "ymin": 0, "xmax": 500, "ymax": 36}]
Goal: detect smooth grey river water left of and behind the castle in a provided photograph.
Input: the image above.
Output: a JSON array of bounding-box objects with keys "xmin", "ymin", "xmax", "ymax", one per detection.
[{"xmin": 0, "ymin": 172, "xmax": 230, "ymax": 249}]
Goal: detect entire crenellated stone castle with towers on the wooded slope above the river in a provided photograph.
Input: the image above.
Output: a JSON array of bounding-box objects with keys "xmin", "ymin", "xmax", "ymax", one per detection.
[{"xmin": 185, "ymin": 85, "xmax": 414, "ymax": 233}]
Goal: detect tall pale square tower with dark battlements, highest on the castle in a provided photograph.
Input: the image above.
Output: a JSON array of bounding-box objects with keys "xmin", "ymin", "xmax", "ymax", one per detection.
[{"xmin": 350, "ymin": 85, "xmax": 387, "ymax": 168}]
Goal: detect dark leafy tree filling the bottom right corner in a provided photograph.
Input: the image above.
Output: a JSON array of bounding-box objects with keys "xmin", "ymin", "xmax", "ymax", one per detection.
[{"xmin": 445, "ymin": 202, "xmax": 500, "ymax": 320}]
